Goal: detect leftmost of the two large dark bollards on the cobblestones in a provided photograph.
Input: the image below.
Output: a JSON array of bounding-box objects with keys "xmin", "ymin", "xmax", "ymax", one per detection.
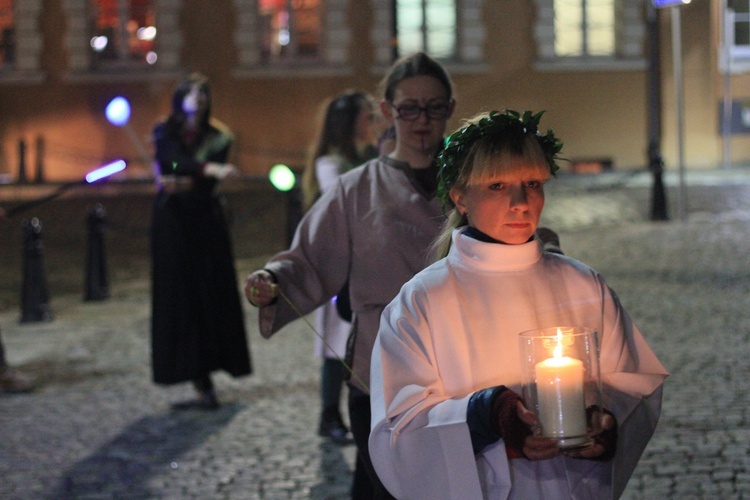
[{"xmin": 21, "ymin": 217, "xmax": 52, "ymax": 323}]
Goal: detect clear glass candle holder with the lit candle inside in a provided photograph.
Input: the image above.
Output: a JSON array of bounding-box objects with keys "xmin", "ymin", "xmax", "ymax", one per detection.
[{"xmin": 519, "ymin": 326, "xmax": 602, "ymax": 450}]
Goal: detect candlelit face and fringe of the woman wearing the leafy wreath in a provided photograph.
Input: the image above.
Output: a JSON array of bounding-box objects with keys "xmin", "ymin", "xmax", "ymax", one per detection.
[{"xmin": 450, "ymin": 158, "xmax": 549, "ymax": 245}]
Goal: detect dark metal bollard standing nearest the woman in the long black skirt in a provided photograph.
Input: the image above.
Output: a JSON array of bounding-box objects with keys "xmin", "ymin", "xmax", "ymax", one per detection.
[{"xmin": 83, "ymin": 203, "xmax": 109, "ymax": 301}]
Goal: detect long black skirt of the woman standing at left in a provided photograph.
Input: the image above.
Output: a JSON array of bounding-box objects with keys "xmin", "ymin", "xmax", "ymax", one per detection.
[{"xmin": 151, "ymin": 191, "xmax": 252, "ymax": 384}]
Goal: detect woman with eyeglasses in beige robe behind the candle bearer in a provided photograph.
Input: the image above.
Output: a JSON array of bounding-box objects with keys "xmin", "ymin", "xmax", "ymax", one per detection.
[{"xmin": 245, "ymin": 53, "xmax": 455, "ymax": 498}]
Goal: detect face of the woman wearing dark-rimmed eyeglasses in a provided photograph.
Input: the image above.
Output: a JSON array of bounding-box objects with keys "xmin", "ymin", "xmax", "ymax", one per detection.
[{"xmin": 380, "ymin": 76, "xmax": 455, "ymax": 168}]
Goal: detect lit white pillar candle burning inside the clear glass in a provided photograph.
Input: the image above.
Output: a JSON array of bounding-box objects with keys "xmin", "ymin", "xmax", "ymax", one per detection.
[{"xmin": 535, "ymin": 329, "xmax": 586, "ymax": 444}]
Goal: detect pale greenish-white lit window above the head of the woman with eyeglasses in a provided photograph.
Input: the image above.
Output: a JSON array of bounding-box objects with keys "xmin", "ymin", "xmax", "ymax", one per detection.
[{"xmin": 394, "ymin": 0, "xmax": 457, "ymax": 59}]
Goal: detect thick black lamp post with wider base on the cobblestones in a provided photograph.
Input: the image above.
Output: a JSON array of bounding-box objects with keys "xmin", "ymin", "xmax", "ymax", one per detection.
[{"xmin": 646, "ymin": 1, "xmax": 669, "ymax": 220}]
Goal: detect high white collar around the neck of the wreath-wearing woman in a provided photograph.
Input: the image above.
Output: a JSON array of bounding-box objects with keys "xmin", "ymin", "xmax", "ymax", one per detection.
[{"xmin": 448, "ymin": 227, "xmax": 542, "ymax": 272}]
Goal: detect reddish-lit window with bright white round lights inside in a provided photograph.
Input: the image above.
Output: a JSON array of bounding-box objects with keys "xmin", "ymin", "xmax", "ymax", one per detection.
[{"xmin": 89, "ymin": 0, "xmax": 157, "ymax": 68}]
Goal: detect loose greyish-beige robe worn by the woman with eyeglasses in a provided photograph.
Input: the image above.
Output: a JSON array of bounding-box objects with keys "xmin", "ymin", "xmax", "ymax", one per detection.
[{"xmin": 259, "ymin": 157, "xmax": 444, "ymax": 392}]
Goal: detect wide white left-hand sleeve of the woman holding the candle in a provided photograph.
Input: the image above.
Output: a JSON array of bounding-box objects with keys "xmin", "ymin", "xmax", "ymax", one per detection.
[{"xmin": 369, "ymin": 290, "xmax": 510, "ymax": 499}]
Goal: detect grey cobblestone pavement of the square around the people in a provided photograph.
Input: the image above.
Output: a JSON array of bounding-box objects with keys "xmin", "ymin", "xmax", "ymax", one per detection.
[{"xmin": 0, "ymin": 169, "xmax": 750, "ymax": 499}]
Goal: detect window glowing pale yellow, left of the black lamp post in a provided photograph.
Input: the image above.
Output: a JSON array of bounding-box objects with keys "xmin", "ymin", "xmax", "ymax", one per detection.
[{"xmin": 554, "ymin": 0, "xmax": 615, "ymax": 57}]
